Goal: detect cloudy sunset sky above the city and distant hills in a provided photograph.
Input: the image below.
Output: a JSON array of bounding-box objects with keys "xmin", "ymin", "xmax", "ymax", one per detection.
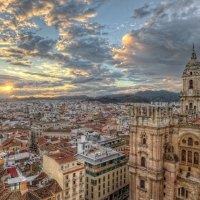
[{"xmin": 0, "ymin": 0, "xmax": 200, "ymax": 98}]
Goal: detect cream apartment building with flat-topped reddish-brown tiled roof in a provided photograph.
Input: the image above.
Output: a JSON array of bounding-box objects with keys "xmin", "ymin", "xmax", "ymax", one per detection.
[{"xmin": 43, "ymin": 152, "xmax": 85, "ymax": 200}]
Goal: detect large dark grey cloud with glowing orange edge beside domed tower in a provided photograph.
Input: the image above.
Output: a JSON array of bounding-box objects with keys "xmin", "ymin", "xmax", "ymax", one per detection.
[{"xmin": 113, "ymin": 0, "xmax": 200, "ymax": 91}]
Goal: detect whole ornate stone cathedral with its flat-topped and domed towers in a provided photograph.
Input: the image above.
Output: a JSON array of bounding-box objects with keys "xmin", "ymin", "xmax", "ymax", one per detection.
[{"xmin": 129, "ymin": 50, "xmax": 200, "ymax": 200}]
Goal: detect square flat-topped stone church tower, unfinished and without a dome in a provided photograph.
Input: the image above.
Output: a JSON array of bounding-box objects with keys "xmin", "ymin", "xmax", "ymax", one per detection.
[{"xmin": 129, "ymin": 106, "xmax": 173, "ymax": 200}]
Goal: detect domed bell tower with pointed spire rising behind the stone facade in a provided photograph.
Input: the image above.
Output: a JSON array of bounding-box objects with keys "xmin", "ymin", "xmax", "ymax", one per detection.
[{"xmin": 180, "ymin": 45, "xmax": 200, "ymax": 117}]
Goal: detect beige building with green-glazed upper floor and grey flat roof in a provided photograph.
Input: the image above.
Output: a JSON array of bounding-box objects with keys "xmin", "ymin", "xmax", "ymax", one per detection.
[{"xmin": 75, "ymin": 136, "xmax": 129, "ymax": 200}]
